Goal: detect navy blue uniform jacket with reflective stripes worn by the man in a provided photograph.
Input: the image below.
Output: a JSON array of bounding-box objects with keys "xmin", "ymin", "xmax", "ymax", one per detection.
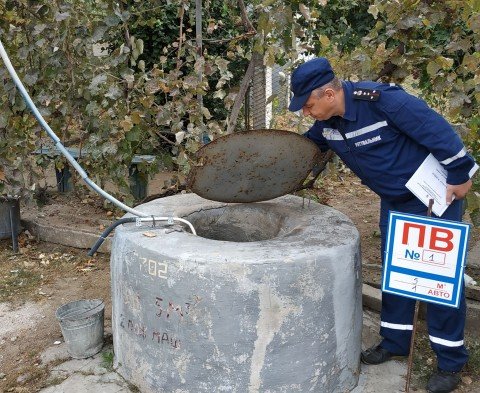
[{"xmin": 305, "ymin": 81, "xmax": 478, "ymax": 202}]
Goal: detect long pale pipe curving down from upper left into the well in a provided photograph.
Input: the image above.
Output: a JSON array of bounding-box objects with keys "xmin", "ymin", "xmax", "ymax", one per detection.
[{"xmin": 0, "ymin": 40, "xmax": 196, "ymax": 235}]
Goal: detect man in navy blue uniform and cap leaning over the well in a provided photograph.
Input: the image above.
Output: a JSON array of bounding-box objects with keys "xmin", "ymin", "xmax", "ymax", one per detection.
[{"xmin": 289, "ymin": 58, "xmax": 478, "ymax": 393}]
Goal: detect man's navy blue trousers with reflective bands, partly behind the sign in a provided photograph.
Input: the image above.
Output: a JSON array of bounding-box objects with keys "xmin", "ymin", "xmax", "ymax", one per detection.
[{"xmin": 380, "ymin": 198, "xmax": 468, "ymax": 371}]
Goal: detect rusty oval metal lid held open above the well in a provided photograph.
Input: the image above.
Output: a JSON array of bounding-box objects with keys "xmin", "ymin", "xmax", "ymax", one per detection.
[{"xmin": 187, "ymin": 130, "xmax": 320, "ymax": 202}]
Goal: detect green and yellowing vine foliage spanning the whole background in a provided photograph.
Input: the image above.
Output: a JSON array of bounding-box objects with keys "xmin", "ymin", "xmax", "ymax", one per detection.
[{"xmin": 0, "ymin": 0, "xmax": 480, "ymax": 211}]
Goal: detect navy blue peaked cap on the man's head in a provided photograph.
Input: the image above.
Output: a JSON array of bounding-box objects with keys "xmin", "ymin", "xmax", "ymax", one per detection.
[{"xmin": 288, "ymin": 57, "xmax": 335, "ymax": 112}]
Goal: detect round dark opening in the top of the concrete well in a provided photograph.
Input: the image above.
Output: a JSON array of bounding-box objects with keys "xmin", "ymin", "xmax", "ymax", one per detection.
[{"xmin": 184, "ymin": 204, "xmax": 284, "ymax": 242}]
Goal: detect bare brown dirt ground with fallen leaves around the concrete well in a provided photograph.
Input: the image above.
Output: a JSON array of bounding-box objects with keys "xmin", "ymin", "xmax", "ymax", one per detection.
[{"xmin": 0, "ymin": 169, "xmax": 480, "ymax": 393}]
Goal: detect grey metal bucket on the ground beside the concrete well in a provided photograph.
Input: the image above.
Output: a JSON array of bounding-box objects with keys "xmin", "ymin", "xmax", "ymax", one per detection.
[{"xmin": 55, "ymin": 299, "xmax": 105, "ymax": 359}]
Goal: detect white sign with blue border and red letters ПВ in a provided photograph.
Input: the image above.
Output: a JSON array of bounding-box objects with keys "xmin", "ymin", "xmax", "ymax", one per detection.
[{"xmin": 382, "ymin": 212, "xmax": 470, "ymax": 308}]
